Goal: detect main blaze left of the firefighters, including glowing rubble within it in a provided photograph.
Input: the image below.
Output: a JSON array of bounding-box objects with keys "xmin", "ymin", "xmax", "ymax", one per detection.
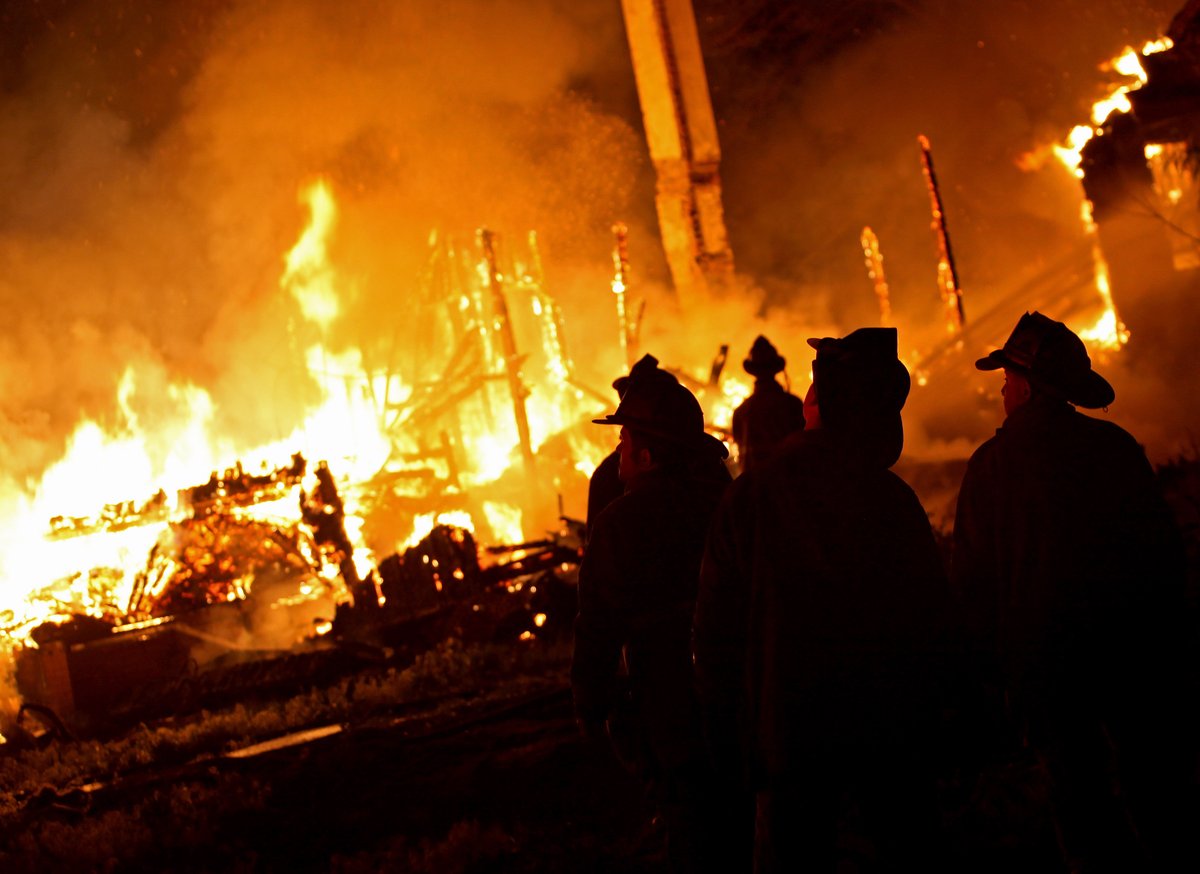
[{"xmin": 0, "ymin": 179, "xmax": 602, "ymax": 645}]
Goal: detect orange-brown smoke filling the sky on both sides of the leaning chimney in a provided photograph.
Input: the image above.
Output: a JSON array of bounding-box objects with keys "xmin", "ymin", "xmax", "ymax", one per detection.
[{"xmin": 0, "ymin": 0, "xmax": 1195, "ymax": 511}]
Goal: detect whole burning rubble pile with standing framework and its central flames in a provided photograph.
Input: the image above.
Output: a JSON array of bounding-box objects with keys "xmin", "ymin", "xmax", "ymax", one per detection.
[{"xmin": 0, "ymin": 165, "xmax": 643, "ymax": 739}]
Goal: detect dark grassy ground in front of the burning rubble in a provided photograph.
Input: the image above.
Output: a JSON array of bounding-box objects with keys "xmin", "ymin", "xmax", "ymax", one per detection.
[{"xmin": 0, "ymin": 645, "xmax": 1084, "ymax": 874}]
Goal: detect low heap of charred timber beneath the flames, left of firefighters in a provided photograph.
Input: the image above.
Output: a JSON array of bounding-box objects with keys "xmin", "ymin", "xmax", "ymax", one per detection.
[{"xmin": 8, "ymin": 455, "xmax": 581, "ymax": 748}]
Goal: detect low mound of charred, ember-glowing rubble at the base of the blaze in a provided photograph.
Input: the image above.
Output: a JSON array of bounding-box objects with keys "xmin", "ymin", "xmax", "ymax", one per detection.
[{"xmin": 0, "ymin": 439, "xmax": 580, "ymax": 724}]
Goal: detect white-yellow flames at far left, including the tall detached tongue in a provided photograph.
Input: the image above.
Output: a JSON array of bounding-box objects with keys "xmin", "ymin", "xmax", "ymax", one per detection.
[{"xmin": 0, "ymin": 180, "xmax": 389, "ymax": 643}]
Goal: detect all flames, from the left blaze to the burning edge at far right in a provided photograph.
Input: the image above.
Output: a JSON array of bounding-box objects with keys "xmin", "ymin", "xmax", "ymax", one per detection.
[{"xmin": 0, "ymin": 6, "xmax": 1190, "ymax": 701}]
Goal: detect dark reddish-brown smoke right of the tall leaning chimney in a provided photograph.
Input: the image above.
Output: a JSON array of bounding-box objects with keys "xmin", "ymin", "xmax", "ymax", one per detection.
[{"xmin": 697, "ymin": 0, "xmax": 1200, "ymax": 459}]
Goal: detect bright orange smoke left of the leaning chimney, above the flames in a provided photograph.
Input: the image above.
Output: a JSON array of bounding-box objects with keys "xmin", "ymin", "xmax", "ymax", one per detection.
[{"xmin": 0, "ymin": 0, "xmax": 648, "ymax": 504}]
